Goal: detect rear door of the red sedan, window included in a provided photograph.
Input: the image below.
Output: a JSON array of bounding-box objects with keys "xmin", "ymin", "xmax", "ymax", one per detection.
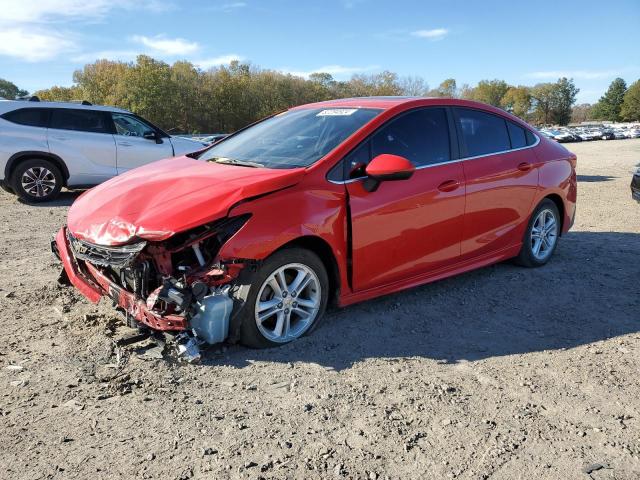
[{"xmin": 454, "ymin": 108, "xmax": 538, "ymax": 260}]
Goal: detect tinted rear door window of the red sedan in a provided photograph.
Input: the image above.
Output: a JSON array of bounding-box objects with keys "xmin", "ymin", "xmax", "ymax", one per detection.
[{"xmin": 456, "ymin": 108, "xmax": 511, "ymax": 157}]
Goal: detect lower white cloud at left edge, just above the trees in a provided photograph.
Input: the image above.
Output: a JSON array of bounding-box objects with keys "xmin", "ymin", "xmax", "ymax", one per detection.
[{"xmin": 0, "ymin": 27, "xmax": 75, "ymax": 62}]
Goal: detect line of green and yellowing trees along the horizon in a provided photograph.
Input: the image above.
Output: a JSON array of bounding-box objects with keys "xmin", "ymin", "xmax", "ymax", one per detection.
[{"xmin": 0, "ymin": 55, "xmax": 640, "ymax": 133}]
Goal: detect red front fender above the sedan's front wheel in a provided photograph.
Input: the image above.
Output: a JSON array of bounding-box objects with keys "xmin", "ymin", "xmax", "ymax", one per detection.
[{"xmin": 218, "ymin": 175, "xmax": 349, "ymax": 295}]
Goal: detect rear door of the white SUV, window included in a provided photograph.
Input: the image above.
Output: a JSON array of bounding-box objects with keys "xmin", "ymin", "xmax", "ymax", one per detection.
[{"xmin": 47, "ymin": 108, "xmax": 117, "ymax": 186}]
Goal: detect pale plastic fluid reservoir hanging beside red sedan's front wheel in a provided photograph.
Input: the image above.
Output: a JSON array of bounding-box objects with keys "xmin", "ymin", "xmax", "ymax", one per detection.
[{"xmin": 190, "ymin": 285, "xmax": 233, "ymax": 344}]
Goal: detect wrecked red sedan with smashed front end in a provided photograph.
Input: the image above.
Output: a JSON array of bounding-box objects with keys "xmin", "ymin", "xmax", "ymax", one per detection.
[{"xmin": 54, "ymin": 97, "xmax": 577, "ymax": 347}]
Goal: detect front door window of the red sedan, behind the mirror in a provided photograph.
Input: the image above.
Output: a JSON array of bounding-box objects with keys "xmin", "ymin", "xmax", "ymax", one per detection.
[{"xmin": 371, "ymin": 108, "xmax": 451, "ymax": 167}]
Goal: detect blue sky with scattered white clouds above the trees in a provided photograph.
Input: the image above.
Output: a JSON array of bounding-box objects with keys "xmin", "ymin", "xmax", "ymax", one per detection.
[{"xmin": 0, "ymin": 0, "xmax": 640, "ymax": 102}]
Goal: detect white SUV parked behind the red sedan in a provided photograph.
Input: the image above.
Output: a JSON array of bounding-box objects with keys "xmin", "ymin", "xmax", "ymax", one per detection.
[{"xmin": 0, "ymin": 98, "xmax": 205, "ymax": 202}]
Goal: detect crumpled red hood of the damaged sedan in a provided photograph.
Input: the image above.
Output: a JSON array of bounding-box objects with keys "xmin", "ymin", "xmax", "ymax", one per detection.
[{"xmin": 67, "ymin": 157, "xmax": 305, "ymax": 245}]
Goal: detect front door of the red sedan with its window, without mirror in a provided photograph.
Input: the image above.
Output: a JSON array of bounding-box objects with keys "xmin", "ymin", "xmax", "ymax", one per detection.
[{"xmin": 345, "ymin": 107, "xmax": 465, "ymax": 291}]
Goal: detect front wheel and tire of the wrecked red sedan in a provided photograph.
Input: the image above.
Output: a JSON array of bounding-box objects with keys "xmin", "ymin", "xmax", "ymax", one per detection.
[{"xmin": 233, "ymin": 248, "xmax": 329, "ymax": 348}]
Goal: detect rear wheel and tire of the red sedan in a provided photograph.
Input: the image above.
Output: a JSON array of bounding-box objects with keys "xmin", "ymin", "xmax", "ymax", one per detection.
[{"xmin": 515, "ymin": 198, "xmax": 561, "ymax": 268}]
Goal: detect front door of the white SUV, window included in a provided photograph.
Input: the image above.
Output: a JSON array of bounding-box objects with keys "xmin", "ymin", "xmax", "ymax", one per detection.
[{"xmin": 111, "ymin": 112, "xmax": 173, "ymax": 173}]
